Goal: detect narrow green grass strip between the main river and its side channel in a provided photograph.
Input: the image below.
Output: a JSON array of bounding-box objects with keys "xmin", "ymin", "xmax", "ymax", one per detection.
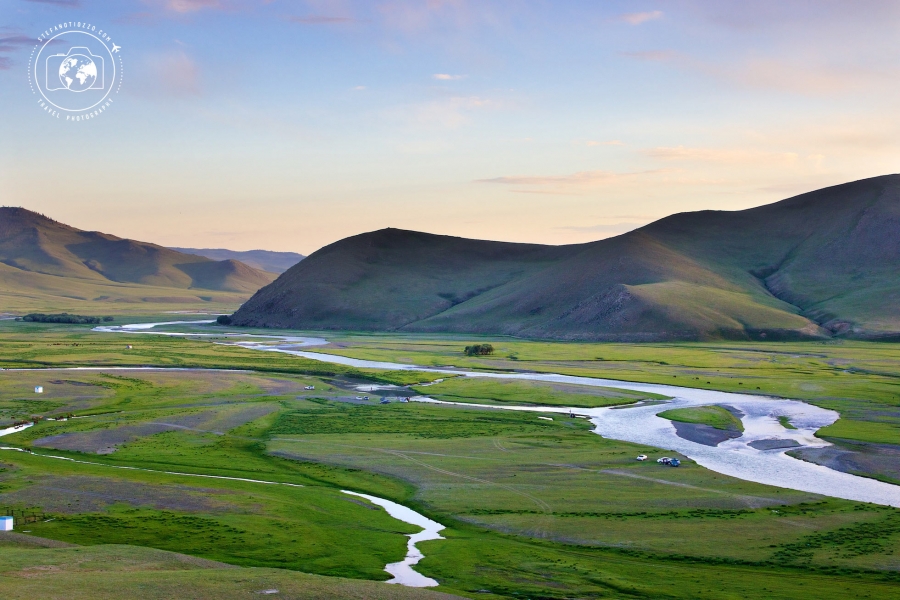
[{"xmin": 412, "ymin": 377, "xmax": 665, "ymax": 408}]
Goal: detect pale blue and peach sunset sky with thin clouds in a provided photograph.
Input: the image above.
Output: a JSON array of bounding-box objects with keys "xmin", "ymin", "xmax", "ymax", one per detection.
[{"xmin": 0, "ymin": 0, "xmax": 900, "ymax": 254}]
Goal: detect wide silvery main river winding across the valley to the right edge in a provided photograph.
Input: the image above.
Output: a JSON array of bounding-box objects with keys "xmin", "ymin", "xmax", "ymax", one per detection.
[{"xmin": 95, "ymin": 321, "xmax": 900, "ymax": 507}]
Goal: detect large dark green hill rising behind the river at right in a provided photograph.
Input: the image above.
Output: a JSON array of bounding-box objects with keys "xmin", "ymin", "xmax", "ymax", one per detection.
[{"xmin": 234, "ymin": 175, "xmax": 900, "ymax": 341}]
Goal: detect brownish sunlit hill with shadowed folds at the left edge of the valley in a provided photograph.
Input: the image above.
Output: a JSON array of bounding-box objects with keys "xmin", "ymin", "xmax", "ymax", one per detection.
[{"xmin": 0, "ymin": 207, "xmax": 275, "ymax": 310}]
